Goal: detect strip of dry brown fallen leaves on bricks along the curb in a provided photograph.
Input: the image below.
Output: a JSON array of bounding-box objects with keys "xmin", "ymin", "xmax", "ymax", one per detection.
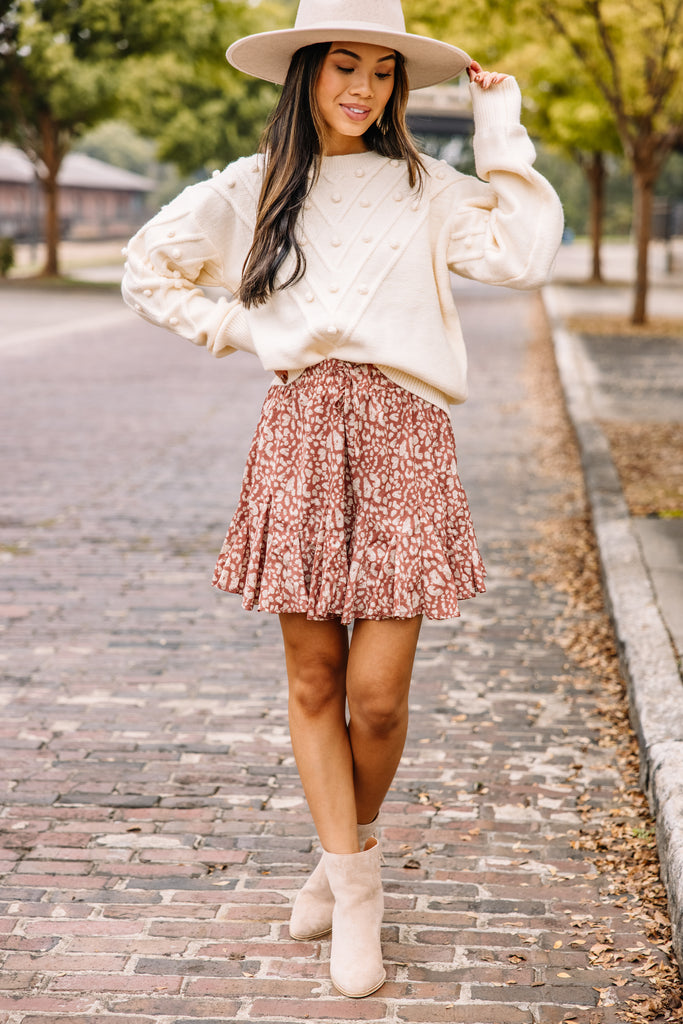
[{"xmin": 527, "ymin": 296, "xmax": 683, "ymax": 1024}]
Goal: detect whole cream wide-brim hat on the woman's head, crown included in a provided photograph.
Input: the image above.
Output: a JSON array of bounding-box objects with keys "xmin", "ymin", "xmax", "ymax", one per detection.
[{"xmin": 225, "ymin": 0, "xmax": 472, "ymax": 89}]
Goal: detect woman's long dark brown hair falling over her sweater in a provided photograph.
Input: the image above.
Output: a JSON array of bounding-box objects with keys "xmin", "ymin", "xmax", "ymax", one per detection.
[{"xmin": 239, "ymin": 43, "xmax": 424, "ymax": 308}]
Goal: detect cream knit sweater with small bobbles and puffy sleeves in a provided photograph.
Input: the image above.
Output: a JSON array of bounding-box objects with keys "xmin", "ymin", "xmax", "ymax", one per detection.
[{"xmin": 123, "ymin": 79, "xmax": 563, "ymax": 408}]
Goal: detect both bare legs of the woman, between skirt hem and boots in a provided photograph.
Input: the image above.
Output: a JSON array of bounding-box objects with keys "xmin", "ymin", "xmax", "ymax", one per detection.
[{"xmin": 280, "ymin": 614, "xmax": 422, "ymax": 853}]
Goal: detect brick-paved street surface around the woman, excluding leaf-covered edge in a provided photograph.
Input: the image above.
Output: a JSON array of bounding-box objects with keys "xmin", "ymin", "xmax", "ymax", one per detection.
[{"xmin": 0, "ymin": 285, "xmax": 671, "ymax": 1024}]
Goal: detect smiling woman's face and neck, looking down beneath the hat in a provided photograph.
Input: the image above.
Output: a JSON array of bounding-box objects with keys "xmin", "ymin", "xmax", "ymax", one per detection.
[{"xmin": 315, "ymin": 42, "xmax": 396, "ymax": 157}]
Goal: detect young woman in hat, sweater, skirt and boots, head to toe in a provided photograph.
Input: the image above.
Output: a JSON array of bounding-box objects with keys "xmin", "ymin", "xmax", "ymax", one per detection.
[{"xmin": 123, "ymin": 0, "xmax": 562, "ymax": 996}]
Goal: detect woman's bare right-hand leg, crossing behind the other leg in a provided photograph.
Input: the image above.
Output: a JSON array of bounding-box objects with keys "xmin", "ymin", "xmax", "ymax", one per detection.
[{"xmin": 346, "ymin": 615, "xmax": 422, "ymax": 823}]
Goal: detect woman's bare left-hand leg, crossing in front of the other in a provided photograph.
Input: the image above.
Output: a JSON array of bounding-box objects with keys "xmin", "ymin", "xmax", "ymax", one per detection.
[{"xmin": 280, "ymin": 614, "xmax": 358, "ymax": 853}]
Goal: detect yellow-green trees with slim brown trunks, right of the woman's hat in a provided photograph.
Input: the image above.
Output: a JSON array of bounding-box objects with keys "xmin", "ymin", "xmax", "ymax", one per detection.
[{"xmin": 404, "ymin": 0, "xmax": 683, "ymax": 315}]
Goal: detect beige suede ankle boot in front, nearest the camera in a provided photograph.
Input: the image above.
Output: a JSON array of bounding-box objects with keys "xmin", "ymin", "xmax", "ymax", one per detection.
[{"xmin": 323, "ymin": 839, "xmax": 386, "ymax": 999}]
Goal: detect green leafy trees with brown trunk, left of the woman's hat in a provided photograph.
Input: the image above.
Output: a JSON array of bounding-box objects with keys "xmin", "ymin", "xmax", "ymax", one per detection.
[{"xmin": 0, "ymin": 0, "xmax": 281, "ymax": 274}]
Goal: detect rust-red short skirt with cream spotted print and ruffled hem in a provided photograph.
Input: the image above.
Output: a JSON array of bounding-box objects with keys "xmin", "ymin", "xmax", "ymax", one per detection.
[{"xmin": 213, "ymin": 359, "xmax": 485, "ymax": 623}]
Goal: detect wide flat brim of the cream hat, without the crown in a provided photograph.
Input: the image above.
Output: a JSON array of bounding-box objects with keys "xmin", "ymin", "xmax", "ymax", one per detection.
[{"xmin": 225, "ymin": 23, "xmax": 472, "ymax": 89}]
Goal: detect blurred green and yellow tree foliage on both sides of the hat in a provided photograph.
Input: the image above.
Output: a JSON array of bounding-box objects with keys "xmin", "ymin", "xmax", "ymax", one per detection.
[{"xmin": 0, "ymin": 0, "xmax": 683, "ymax": 311}]
